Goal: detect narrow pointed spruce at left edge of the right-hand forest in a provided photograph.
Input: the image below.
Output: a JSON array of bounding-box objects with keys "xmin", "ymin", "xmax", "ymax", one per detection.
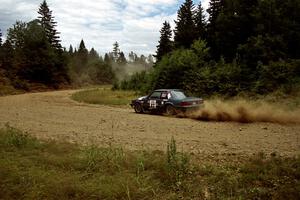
[{"xmin": 155, "ymin": 21, "xmax": 173, "ymax": 61}]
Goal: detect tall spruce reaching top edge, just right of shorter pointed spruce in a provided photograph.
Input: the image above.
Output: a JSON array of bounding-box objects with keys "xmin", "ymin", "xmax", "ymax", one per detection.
[{"xmin": 174, "ymin": 0, "xmax": 197, "ymax": 48}]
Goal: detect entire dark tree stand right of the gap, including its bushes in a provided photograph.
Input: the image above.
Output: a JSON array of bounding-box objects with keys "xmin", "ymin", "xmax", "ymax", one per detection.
[{"xmin": 119, "ymin": 0, "xmax": 300, "ymax": 96}]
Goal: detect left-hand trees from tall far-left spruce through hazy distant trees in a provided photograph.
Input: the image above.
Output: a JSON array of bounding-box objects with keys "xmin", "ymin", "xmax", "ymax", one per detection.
[{"xmin": 0, "ymin": 1, "xmax": 153, "ymax": 93}]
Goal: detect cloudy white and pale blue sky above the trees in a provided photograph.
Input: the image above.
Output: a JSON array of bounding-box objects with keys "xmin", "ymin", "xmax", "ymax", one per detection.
[{"xmin": 0, "ymin": 0, "xmax": 209, "ymax": 55}]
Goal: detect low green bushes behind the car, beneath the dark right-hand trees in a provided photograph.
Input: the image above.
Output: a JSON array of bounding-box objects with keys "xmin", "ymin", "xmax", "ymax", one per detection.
[{"xmin": 136, "ymin": 40, "xmax": 300, "ymax": 96}]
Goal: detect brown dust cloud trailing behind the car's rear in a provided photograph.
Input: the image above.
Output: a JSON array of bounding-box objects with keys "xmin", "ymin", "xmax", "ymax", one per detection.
[{"xmin": 178, "ymin": 100, "xmax": 300, "ymax": 124}]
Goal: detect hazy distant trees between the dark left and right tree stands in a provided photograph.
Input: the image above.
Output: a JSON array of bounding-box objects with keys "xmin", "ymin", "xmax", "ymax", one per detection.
[{"xmin": 66, "ymin": 40, "xmax": 153, "ymax": 86}]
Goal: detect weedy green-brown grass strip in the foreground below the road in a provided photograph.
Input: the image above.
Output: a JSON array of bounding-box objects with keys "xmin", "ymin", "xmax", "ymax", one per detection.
[{"xmin": 0, "ymin": 126, "xmax": 300, "ymax": 199}]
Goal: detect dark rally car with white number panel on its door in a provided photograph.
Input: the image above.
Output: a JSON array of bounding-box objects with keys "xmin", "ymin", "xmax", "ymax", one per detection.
[{"xmin": 130, "ymin": 89, "xmax": 204, "ymax": 115}]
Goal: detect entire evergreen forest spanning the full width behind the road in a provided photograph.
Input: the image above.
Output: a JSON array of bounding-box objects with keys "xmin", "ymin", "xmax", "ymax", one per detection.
[{"xmin": 0, "ymin": 0, "xmax": 300, "ymax": 96}]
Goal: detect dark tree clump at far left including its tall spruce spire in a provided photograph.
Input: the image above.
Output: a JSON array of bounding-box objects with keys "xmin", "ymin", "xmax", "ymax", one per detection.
[{"xmin": 0, "ymin": 1, "xmax": 69, "ymax": 91}]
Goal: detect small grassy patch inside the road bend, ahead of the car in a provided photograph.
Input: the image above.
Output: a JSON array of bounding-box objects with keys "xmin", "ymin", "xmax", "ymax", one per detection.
[{"xmin": 72, "ymin": 87, "xmax": 138, "ymax": 106}]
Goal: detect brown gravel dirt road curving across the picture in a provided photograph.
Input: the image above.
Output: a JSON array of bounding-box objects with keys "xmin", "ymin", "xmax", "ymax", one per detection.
[{"xmin": 0, "ymin": 91, "xmax": 300, "ymax": 156}]
